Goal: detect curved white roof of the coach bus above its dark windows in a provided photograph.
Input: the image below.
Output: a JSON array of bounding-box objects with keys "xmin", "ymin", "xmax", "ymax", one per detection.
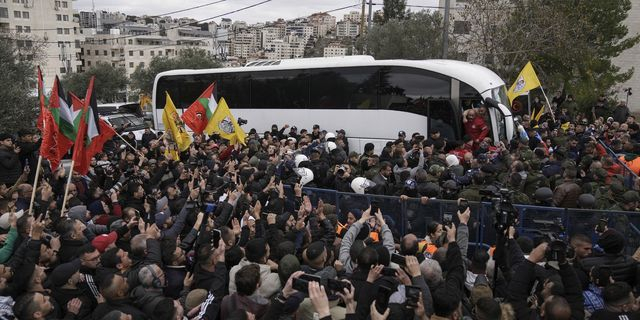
[{"xmin": 155, "ymin": 56, "xmax": 505, "ymax": 93}]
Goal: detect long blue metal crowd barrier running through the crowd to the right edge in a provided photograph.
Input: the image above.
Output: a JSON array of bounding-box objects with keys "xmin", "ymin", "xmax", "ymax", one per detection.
[{"xmin": 285, "ymin": 187, "xmax": 640, "ymax": 254}]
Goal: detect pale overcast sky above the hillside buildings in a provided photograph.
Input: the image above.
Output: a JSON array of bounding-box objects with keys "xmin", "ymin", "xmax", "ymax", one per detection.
[{"xmin": 73, "ymin": 0, "xmax": 437, "ymax": 23}]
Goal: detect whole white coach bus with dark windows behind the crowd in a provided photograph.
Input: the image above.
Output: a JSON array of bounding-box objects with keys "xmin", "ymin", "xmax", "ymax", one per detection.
[{"xmin": 153, "ymin": 56, "xmax": 514, "ymax": 152}]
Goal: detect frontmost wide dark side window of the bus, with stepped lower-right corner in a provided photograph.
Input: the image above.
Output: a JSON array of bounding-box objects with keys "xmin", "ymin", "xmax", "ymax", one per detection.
[{"xmin": 378, "ymin": 67, "xmax": 451, "ymax": 115}]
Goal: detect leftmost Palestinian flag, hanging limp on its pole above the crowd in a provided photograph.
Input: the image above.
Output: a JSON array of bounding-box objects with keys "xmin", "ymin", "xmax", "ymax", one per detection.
[{"xmin": 47, "ymin": 76, "xmax": 76, "ymax": 169}]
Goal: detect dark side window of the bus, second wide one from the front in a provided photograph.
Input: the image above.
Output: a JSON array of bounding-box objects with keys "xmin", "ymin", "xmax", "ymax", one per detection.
[{"xmin": 309, "ymin": 67, "xmax": 378, "ymax": 109}]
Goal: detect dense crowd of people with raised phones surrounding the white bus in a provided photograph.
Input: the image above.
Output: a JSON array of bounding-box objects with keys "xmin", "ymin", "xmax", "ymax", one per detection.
[{"xmin": 0, "ymin": 95, "xmax": 640, "ymax": 320}]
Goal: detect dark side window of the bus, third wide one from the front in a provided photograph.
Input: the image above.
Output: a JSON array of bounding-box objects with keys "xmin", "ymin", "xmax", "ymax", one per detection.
[{"xmin": 251, "ymin": 70, "xmax": 309, "ymax": 109}]
